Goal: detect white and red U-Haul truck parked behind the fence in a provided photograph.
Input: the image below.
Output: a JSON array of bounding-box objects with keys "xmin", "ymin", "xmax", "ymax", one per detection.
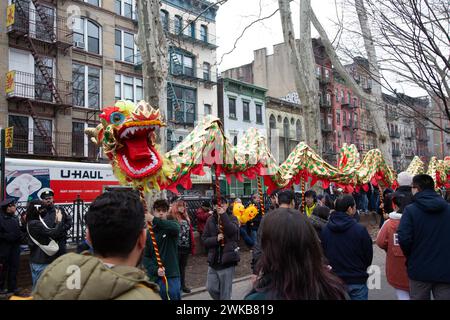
[{"xmin": 5, "ymin": 158, "xmax": 119, "ymax": 203}]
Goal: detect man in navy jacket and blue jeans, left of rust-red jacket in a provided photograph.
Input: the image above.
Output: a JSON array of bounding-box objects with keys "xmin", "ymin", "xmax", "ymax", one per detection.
[{"xmin": 321, "ymin": 195, "xmax": 373, "ymax": 300}]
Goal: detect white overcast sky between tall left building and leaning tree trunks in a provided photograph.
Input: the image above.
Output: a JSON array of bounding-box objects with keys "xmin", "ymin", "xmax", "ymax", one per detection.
[{"xmin": 216, "ymin": 0, "xmax": 337, "ymax": 71}]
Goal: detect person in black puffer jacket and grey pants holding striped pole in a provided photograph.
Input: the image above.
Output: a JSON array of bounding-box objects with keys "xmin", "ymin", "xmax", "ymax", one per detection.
[{"xmin": 202, "ymin": 198, "xmax": 240, "ymax": 300}]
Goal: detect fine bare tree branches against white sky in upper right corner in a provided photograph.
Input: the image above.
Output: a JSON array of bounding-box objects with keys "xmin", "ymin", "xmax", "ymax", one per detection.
[{"xmin": 367, "ymin": 0, "xmax": 450, "ymax": 120}]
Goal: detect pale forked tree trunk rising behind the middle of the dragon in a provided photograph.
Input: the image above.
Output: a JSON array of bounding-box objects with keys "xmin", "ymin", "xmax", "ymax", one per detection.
[{"xmin": 278, "ymin": 0, "xmax": 322, "ymax": 154}]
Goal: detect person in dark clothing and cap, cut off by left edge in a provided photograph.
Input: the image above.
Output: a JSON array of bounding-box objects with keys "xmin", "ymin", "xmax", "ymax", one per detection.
[{"xmin": 0, "ymin": 199, "xmax": 24, "ymax": 294}]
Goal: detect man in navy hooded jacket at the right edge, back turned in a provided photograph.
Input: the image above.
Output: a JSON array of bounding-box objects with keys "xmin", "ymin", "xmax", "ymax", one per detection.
[{"xmin": 397, "ymin": 174, "xmax": 450, "ymax": 300}]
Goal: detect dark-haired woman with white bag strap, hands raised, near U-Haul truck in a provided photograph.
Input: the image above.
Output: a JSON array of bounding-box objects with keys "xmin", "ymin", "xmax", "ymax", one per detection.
[{"xmin": 26, "ymin": 200, "xmax": 65, "ymax": 289}]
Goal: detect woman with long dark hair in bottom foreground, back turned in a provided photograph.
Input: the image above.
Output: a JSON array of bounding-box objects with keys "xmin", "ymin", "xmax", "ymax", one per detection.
[{"xmin": 245, "ymin": 209, "xmax": 346, "ymax": 300}]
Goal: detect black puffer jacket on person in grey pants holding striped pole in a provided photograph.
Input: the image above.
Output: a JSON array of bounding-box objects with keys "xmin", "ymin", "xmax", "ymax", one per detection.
[{"xmin": 202, "ymin": 211, "xmax": 240, "ymax": 270}]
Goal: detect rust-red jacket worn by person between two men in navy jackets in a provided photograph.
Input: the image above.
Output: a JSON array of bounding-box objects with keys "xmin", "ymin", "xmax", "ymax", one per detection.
[{"xmin": 377, "ymin": 212, "xmax": 409, "ymax": 291}]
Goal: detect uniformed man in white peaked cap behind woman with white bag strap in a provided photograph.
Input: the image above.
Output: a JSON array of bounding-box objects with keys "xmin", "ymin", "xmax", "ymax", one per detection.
[{"xmin": 41, "ymin": 190, "xmax": 73, "ymax": 257}]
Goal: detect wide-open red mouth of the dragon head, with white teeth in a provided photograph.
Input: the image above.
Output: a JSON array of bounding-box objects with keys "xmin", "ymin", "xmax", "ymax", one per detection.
[{"xmin": 117, "ymin": 123, "xmax": 162, "ymax": 179}]
